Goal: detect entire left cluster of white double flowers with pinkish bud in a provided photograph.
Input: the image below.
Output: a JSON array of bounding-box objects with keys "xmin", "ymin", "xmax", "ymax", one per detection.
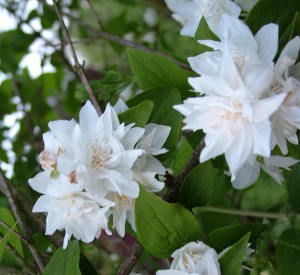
[{"xmin": 29, "ymin": 101, "xmax": 170, "ymax": 248}]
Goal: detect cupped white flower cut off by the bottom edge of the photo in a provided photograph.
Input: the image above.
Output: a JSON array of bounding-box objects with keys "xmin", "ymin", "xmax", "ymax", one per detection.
[{"xmin": 156, "ymin": 242, "xmax": 221, "ymax": 275}]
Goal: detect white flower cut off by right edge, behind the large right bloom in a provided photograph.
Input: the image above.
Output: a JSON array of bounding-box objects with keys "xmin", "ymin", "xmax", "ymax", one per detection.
[{"xmin": 271, "ymin": 36, "xmax": 300, "ymax": 154}]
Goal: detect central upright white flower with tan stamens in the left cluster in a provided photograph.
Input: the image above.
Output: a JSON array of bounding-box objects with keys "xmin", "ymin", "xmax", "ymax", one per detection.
[{"xmin": 58, "ymin": 101, "xmax": 144, "ymax": 199}]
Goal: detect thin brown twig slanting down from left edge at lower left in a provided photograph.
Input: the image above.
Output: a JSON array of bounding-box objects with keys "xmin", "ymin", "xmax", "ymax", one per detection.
[{"xmin": 0, "ymin": 170, "xmax": 44, "ymax": 273}]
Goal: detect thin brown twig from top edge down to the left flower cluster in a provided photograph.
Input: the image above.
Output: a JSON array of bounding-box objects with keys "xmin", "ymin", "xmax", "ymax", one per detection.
[{"xmin": 52, "ymin": 0, "xmax": 102, "ymax": 116}]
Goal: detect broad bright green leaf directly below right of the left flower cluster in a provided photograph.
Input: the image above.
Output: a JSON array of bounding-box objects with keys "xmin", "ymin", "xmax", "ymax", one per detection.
[{"xmin": 135, "ymin": 188, "xmax": 200, "ymax": 258}]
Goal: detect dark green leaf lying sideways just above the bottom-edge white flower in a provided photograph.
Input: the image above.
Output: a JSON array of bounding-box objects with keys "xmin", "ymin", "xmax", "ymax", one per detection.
[{"xmin": 205, "ymin": 223, "xmax": 267, "ymax": 253}]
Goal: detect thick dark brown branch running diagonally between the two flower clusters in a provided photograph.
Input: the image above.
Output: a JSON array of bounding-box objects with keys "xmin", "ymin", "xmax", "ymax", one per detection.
[{"xmin": 118, "ymin": 138, "xmax": 205, "ymax": 275}]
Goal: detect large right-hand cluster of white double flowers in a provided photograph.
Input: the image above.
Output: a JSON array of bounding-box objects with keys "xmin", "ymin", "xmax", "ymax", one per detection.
[{"xmin": 174, "ymin": 3, "xmax": 300, "ymax": 189}]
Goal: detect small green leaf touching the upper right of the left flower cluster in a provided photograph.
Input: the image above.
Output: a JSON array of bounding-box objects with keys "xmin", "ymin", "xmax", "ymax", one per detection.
[{"xmin": 118, "ymin": 100, "xmax": 154, "ymax": 127}]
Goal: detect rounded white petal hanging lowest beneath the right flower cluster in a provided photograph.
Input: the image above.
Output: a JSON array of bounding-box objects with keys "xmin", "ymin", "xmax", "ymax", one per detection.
[{"xmin": 232, "ymin": 161, "xmax": 260, "ymax": 189}]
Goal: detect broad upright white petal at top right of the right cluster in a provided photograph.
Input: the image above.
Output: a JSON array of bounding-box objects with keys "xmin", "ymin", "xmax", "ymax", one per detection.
[{"xmin": 255, "ymin": 24, "xmax": 278, "ymax": 61}]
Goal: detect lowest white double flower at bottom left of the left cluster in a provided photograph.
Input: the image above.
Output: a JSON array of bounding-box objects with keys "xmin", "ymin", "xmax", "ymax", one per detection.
[{"xmin": 29, "ymin": 171, "xmax": 113, "ymax": 248}]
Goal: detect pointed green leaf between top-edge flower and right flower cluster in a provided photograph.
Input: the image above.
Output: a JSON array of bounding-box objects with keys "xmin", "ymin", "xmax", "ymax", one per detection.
[{"xmin": 192, "ymin": 16, "xmax": 220, "ymax": 56}]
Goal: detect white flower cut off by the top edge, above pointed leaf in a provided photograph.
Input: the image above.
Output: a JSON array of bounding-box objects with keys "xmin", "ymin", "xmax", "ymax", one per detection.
[{"xmin": 167, "ymin": 0, "xmax": 241, "ymax": 37}]
